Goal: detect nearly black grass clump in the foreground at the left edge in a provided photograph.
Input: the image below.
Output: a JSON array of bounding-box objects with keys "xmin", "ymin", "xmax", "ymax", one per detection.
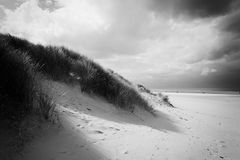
[{"xmin": 0, "ymin": 35, "xmax": 58, "ymax": 124}]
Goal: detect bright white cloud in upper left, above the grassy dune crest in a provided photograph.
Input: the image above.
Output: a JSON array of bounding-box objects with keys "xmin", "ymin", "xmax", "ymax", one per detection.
[{"xmin": 1, "ymin": 0, "xmax": 107, "ymax": 48}]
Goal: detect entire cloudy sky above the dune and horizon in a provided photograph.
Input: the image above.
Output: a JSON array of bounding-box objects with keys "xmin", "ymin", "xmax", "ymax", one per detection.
[{"xmin": 0, "ymin": 0, "xmax": 240, "ymax": 90}]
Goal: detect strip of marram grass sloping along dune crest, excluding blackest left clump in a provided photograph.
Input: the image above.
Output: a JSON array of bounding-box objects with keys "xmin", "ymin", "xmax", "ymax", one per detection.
[{"xmin": 0, "ymin": 32, "xmax": 152, "ymax": 111}]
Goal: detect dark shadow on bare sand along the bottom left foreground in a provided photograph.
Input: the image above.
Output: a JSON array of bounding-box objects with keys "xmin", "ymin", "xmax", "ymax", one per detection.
[{"xmin": 14, "ymin": 122, "xmax": 107, "ymax": 160}]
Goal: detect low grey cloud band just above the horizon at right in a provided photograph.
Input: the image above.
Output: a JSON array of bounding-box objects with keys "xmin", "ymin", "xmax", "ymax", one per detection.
[{"xmin": 148, "ymin": 60, "xmax": 240, "ymax": 91}]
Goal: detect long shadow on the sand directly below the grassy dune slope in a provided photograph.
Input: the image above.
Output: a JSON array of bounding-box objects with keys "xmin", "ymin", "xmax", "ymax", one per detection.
[{"xmin": 45, "ymin": 79, "xmax": 181, "ymax": 132}]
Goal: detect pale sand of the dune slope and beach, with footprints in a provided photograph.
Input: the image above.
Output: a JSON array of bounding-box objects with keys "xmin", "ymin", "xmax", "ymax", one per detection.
[{"xmin": 19, "ymin": 83, "xmax": 240, "ymax": 160}]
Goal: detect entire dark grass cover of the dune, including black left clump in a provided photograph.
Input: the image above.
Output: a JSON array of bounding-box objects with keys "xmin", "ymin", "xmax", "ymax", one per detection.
[{"xmin": 0, "ymin": 34, "xmax": 152, "ymax": 122}]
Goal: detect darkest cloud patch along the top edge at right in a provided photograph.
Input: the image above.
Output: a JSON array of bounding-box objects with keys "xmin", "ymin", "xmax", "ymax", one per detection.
[{"xmin": 149, "ymin": 0, "xmax": 236, "ymax": 18}]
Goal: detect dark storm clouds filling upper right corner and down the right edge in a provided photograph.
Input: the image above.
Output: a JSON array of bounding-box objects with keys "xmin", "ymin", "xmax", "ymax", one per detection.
[{"xmin": 148, "ymin": 0, "xmax": 240, "ymax": 62}]
